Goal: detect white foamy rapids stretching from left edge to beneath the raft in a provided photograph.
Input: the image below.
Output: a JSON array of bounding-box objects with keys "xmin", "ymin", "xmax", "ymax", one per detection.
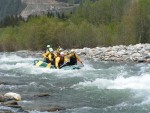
[{"xmin": 0, "ymin": 53, "xmax": 94, "ymax": 77}]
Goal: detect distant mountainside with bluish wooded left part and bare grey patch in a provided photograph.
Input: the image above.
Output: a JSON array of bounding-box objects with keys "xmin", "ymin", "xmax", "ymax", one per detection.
[{"xmin": 0, "ymin": 0, "xmax": 81, "ymax": 20}]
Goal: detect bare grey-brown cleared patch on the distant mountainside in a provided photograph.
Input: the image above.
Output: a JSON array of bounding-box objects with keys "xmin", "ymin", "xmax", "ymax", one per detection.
[{"xmin": 21, "ymin": 0, "xmax": 75, "ymax": 18}]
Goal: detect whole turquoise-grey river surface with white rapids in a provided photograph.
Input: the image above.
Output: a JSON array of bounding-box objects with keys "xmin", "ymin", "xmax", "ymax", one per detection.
[{"xmin": 0, "ymin": 52, "xmax": 150, "ymax": 113}]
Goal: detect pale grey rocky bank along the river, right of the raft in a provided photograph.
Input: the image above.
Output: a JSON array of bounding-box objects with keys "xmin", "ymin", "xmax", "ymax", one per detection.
[{"xmin": 76, "ymin": 44, "xmax": 150, "ymax": 63}]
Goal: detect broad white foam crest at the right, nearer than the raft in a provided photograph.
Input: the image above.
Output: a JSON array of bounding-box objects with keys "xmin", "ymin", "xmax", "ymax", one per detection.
[{"xmin": 72, "ymin": 74, "xmax": 150, "ymax": 90}]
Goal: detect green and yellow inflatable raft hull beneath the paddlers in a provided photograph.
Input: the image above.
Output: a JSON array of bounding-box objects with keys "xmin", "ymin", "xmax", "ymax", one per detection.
[{"xmin": 34, "ymin": 60, "xmax": 81, "ymax": 70}]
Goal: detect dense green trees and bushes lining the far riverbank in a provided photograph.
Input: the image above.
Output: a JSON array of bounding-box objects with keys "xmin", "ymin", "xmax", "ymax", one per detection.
[{"xmin": 0, "ymin": 0, "xmax": 150, "ymax": 51}]
